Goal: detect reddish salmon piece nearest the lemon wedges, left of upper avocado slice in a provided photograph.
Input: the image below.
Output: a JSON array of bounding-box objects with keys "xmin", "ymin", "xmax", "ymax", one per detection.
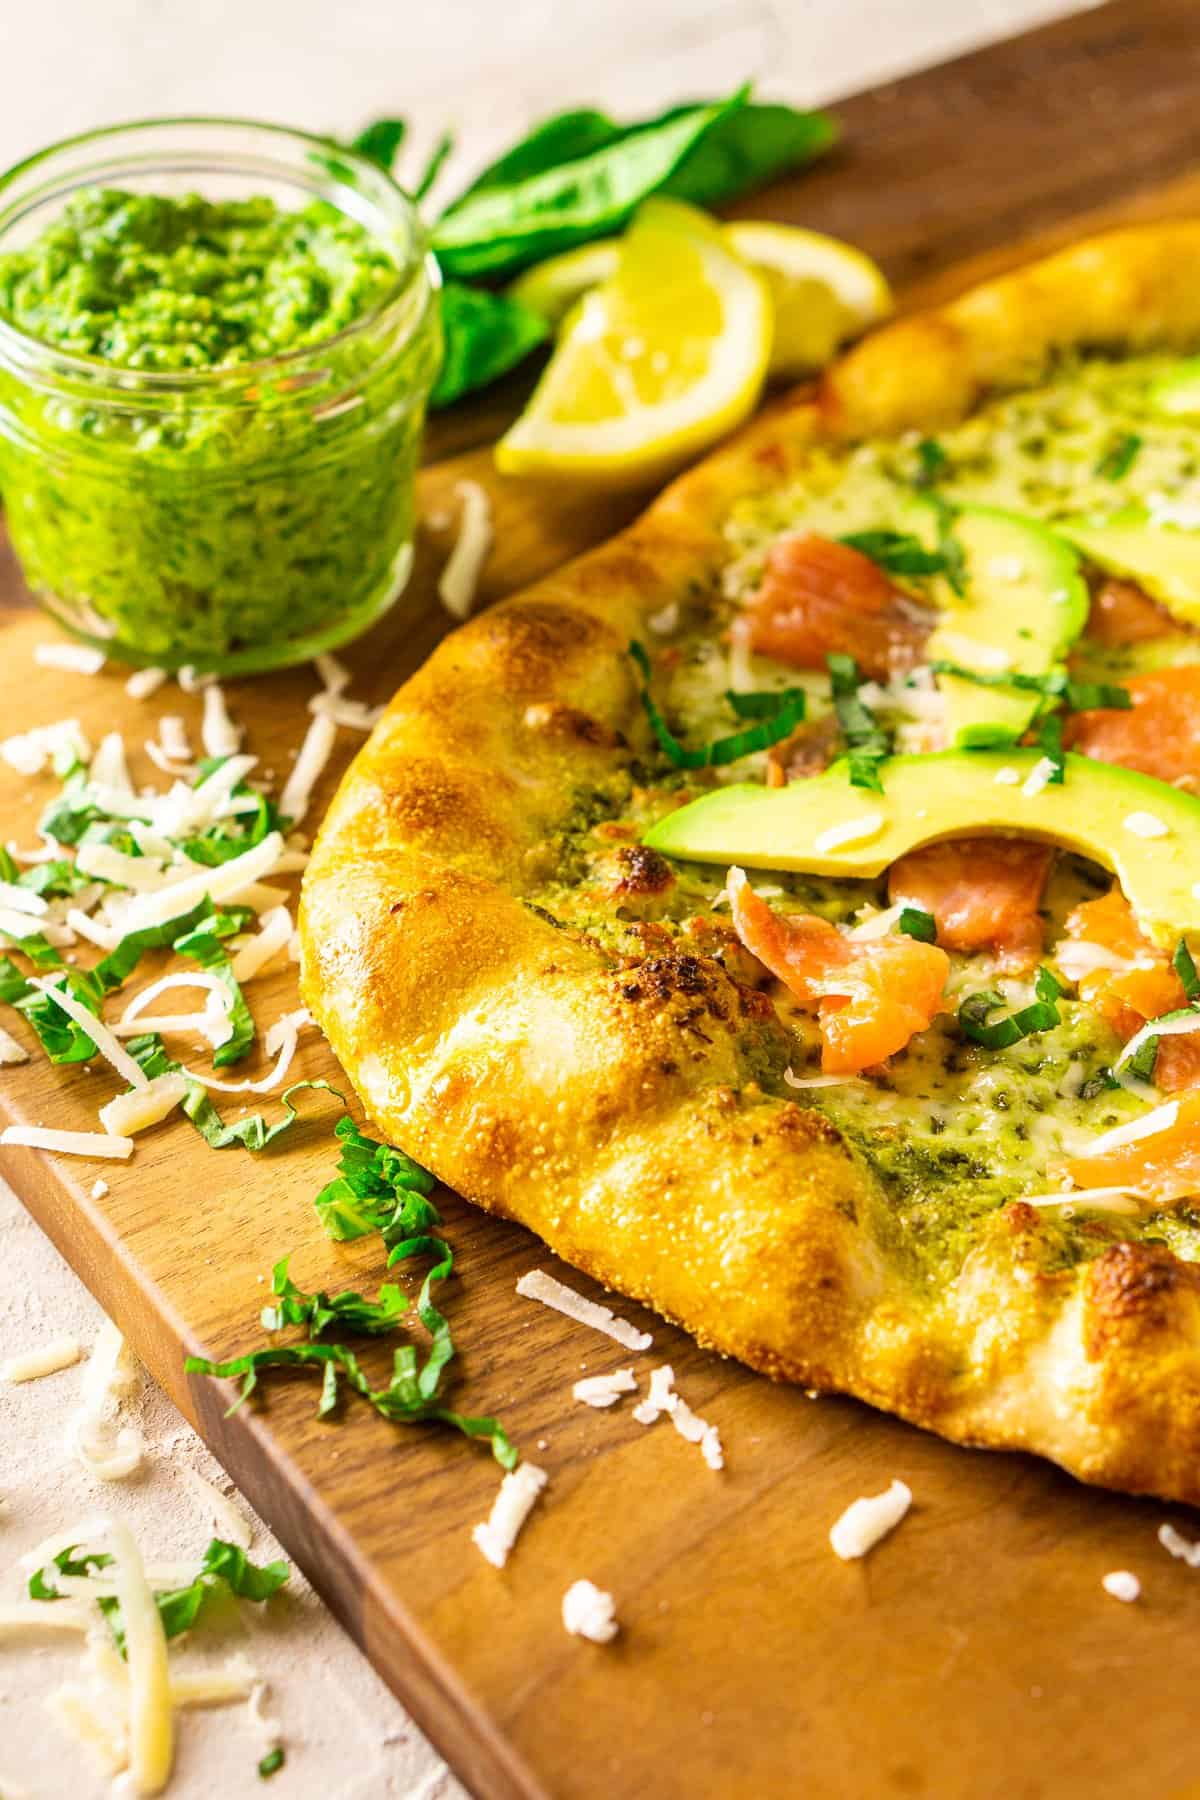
[{"xmin": 734, "ymin": 535, "xmax": 934, "ymax": 680}]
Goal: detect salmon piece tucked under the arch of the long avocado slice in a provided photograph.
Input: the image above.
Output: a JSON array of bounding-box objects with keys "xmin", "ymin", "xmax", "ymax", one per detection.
[{"xmin": 887, "ymin": 837, "xmax": 1054, "ymax": 967}]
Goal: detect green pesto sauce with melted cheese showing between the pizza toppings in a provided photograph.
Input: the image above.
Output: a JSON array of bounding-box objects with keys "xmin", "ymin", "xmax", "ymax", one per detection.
[{"xmin": 529, "ymin": 355, "xmax": 1200, "ymax": 1274}]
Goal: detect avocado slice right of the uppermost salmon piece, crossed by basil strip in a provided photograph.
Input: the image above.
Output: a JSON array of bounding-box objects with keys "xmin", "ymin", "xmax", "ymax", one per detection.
[{"xmin": 913, "ymin": 506, "xmax": 1088, "ymax": 749}]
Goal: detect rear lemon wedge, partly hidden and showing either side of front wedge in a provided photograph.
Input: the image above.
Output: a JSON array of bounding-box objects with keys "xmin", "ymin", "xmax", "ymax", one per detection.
[{"xmin": 509, "ymin": 220, "xmax": 894, "ymax": 378}]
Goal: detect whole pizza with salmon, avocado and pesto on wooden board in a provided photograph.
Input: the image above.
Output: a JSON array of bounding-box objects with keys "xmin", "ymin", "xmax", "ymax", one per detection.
[{"xmin": 300, "ymin": 223, "xmax": 1200, "ymax": 1501}]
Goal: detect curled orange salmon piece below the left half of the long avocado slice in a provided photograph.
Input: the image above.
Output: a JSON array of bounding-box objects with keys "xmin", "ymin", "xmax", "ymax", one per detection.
[{"xmin": 727, "ymin": 869, "xmax": 950, "ymax": 1075}]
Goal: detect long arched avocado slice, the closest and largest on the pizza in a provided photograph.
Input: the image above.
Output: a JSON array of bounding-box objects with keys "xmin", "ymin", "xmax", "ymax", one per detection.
[{"xmin": 642, "ymin": 751, "xmax": 1200, "ymax": 945}]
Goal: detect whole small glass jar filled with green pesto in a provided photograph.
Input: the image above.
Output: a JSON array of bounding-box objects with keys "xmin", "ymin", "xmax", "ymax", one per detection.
[{"xmin": 0, "ymin": 119, "xmax": 441, "ymax": 675}]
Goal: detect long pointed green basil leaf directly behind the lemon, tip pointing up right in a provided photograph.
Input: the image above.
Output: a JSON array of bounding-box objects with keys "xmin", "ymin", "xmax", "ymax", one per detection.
[{"xmin": 432, "ymin": 88, "xmax": 748, "ymax": 277}]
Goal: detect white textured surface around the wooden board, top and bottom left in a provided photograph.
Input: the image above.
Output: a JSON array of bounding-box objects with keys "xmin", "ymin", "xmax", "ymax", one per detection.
[{"xmin": 0, "ymin": 0, "xmax": 1074, "ymax": 1800}]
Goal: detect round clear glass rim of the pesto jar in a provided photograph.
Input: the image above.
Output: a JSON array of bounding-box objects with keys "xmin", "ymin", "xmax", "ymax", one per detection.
[{"xmin": 0, "ymin": 113, "xmax": 441, "ymax": 398}]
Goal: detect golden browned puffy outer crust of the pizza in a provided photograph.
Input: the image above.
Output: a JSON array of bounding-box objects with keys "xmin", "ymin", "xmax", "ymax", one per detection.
[{"xmin": 300, "ymin": 223, "xmax": 1200, "ymax": 1501}]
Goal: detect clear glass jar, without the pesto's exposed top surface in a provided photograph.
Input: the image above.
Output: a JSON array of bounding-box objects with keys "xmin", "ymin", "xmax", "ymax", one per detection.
[{"xmin": 0, "ymin": 119, "xmax": 441, "ymax": 675}]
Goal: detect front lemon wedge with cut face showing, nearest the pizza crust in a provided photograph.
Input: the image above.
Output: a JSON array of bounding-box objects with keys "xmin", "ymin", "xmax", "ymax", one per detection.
[{"xmin": 497, "ymin": 200, "xmax": 772, "ymax": 486}]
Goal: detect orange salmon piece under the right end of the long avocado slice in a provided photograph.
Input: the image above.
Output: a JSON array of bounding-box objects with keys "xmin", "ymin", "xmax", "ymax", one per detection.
[{"xmin": 1067, "ymin": 887, "xmax": 1200, "ymax": 1094}]
